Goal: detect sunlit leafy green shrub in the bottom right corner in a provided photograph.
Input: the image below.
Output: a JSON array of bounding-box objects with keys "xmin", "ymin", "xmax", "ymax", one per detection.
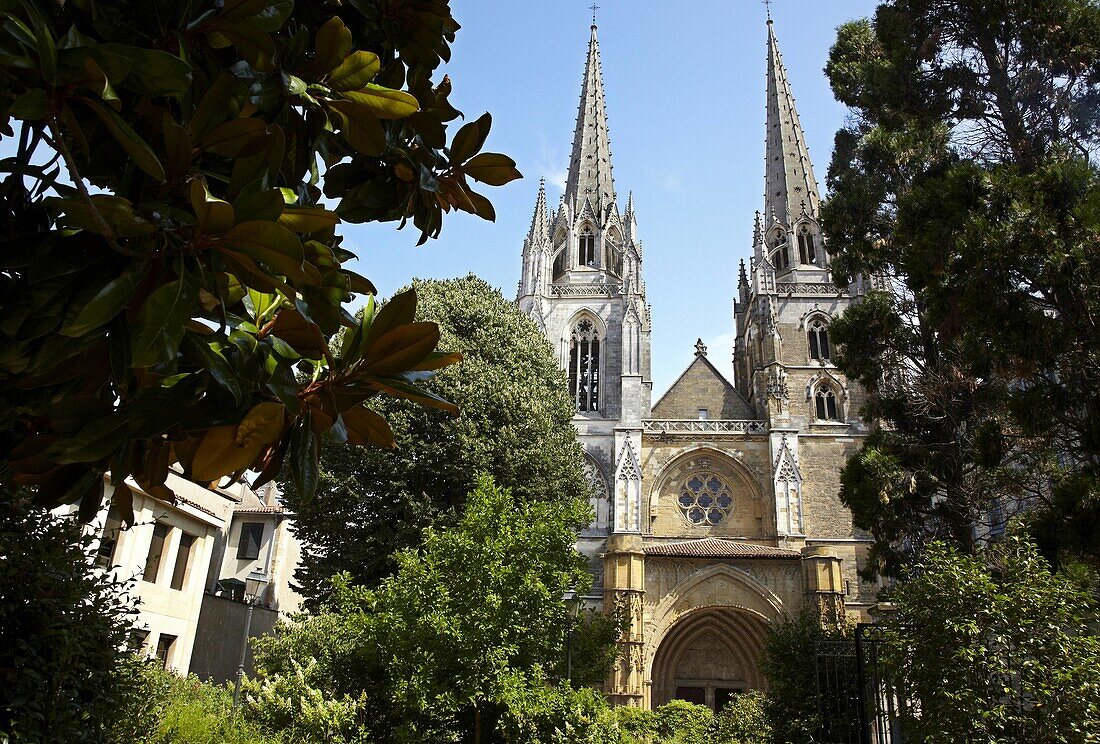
[{"xmin": 887, "ymin": 536, "xmax": 1100, "ymax": 744}]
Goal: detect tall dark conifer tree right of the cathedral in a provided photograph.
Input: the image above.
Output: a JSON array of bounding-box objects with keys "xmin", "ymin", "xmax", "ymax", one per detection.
[{"xmin": 822, "ymin": 0, "xmax": 1100, "ymax": 572}]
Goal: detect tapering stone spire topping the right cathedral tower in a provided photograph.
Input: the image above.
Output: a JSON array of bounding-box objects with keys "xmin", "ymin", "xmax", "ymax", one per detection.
[{"xmin": 763, "ymin": 19, "xmax": 821, "ymax": 227}]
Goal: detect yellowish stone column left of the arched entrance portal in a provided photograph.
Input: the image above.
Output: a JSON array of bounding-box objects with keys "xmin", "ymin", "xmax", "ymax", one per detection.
[{"xmin": 604, "ymin": 534, "xmax": 646, "ymax": 708}]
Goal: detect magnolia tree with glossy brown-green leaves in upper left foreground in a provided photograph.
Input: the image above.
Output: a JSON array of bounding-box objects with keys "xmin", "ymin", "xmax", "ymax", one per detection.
[{"xmin": 0, "ymin": 0, "xmax": 519, "ymax": 522}]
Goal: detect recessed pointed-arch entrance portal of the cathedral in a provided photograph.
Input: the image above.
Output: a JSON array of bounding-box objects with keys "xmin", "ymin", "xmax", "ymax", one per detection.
[{"xmin": 650, "ymin": 608, "xmax": 766, "ymax": 711}]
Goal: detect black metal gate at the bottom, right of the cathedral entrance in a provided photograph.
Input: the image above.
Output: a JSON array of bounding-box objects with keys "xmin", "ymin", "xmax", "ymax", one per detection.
[{"xmin": 815, "ymin": 623, "xmax": 912, "ymax": 744}]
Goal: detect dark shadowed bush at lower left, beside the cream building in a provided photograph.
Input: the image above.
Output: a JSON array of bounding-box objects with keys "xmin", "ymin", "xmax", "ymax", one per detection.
[{"xmin": 0, "ymin": 492, "xmax": 132, "ymax": 744}]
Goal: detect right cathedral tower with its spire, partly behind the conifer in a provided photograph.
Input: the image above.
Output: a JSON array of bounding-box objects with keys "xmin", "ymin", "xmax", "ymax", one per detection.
[{"xmin": 734, "ymin": 19, "xmax": 866, "ymax": 559}]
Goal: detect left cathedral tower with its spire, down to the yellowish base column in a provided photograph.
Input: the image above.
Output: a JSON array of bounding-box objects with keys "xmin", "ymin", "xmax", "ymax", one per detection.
[{"xmin": 517, "ymin": 23, "xmax": 652, "ymax": 704}]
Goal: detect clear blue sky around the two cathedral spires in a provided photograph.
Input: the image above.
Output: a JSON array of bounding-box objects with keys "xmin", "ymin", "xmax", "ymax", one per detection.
[{"xmin": 344, "ymin": 0, "xmax": 876, "ymax": 402}]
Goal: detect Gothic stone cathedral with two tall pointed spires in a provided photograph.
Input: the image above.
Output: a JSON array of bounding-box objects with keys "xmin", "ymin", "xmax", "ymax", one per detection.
[{"xmin": 517, "ymin": 20, "xmax": 877, "ymax": 710}]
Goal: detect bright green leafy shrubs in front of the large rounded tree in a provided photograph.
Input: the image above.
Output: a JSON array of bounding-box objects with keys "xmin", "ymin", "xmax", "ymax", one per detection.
[{"xmin": 249, "ymin": 477, "xmax": 591, "ymax": 743}]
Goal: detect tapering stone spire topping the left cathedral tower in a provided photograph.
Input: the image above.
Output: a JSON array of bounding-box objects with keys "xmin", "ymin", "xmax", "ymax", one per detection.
[{"xmin": 565, "ymin": 24, "xmax": 615, "ymax": 217}]
